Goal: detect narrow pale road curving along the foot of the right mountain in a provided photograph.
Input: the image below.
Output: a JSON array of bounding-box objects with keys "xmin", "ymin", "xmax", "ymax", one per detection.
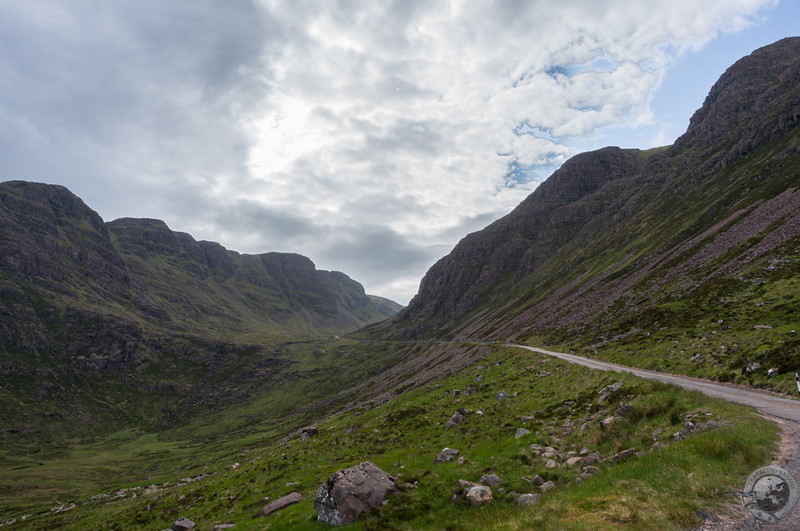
[{"xmin": 509, "ymin": 345, "xmax": 800, "ymax": 531}]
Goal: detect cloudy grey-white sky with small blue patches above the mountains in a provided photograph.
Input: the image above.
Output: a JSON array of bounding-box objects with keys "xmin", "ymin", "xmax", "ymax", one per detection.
[{"xmin": 0, "ymin": 0, "xmax": 800, "ymax": 304}]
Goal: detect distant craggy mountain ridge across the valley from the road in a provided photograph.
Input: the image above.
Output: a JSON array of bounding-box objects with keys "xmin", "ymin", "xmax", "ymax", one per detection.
[{"xmin": 0, "ymin": 181, "xmax": 400, "ymax": 445}]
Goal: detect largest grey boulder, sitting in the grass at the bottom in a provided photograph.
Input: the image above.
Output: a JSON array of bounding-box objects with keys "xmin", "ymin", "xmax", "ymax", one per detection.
[{"xmin": 314, "ymin": 461, "xmax": 397, "ymax": 526}]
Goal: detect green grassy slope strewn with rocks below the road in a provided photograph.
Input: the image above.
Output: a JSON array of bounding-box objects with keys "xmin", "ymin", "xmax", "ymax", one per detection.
[{"xmin": 1, "ymin": 347, "xmax": 777, "ymax": 530}]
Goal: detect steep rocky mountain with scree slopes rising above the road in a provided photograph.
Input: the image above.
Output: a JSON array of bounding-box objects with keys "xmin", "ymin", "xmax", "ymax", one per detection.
[{"xmin": 371, "ymin": 38, "xmax": 800, "ymax": 376}]
